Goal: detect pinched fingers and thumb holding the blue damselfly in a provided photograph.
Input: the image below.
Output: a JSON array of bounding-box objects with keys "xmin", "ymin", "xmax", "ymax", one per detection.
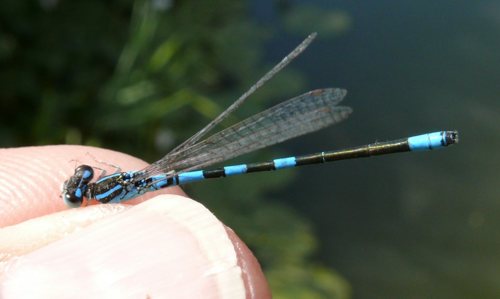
[{"xmin": 0, "ymin": 146, "xmax": 271, "ymax": 298}]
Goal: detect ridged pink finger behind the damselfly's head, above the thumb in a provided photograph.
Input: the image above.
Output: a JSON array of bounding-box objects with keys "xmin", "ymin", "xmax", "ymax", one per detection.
[{"xmin": 0, "ymin": 145, "xmax": 184, "ymax": 227}]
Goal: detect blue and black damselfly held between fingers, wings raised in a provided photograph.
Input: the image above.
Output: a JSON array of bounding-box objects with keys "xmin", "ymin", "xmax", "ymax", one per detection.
[{"xmin": 62, "ymin": 33, "xmax": 458, "ymax": 207}]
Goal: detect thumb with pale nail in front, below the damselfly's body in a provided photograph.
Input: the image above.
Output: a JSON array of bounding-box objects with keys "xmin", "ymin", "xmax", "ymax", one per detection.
[{"xmin": 2, "ymin": 195, "xmax": 269, "ymax": 298}]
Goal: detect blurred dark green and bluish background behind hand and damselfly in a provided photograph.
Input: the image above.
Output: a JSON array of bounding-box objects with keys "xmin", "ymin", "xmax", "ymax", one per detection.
[{"xmin": 0, "ymin": 0, "xmax": 500, "ymax": 298}]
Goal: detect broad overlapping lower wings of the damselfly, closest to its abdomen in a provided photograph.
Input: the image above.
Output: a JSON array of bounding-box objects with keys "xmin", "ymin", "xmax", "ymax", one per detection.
[{"xmin": 143, "ymin": 88, "xmax": 352, "ymax": 177}]
